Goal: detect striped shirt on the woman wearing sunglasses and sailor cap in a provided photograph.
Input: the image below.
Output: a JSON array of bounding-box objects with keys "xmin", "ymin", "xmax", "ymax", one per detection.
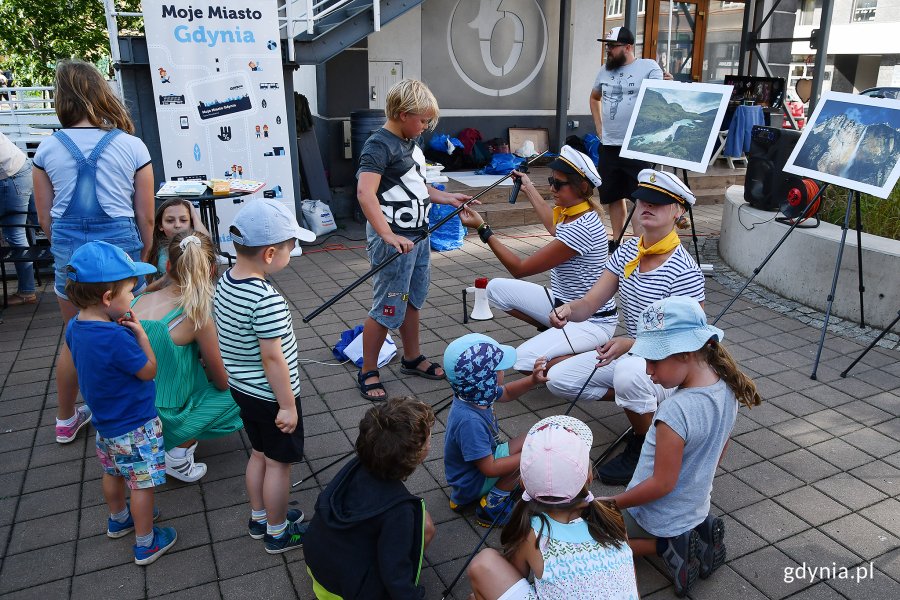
[{"xmin": 550, "ymin": 210, "xmax": 616, "ymax": 323}]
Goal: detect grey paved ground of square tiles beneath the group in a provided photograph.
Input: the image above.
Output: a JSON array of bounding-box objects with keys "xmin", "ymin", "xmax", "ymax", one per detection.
[{"xmin": 0, "ymin": 206, "xmax": 900, "ymax": 600}]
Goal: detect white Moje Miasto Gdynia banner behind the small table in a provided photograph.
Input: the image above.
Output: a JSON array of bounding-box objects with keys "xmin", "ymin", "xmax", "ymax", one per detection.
[{"xmin": 143, "ymin": 0, "xmax": 295, "ymax": 251}]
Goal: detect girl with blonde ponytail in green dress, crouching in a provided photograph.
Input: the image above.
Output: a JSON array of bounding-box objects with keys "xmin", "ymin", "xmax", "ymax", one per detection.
[{"xmin": 132, "ymin": 231, "xmax": 243, "ymax": 482}]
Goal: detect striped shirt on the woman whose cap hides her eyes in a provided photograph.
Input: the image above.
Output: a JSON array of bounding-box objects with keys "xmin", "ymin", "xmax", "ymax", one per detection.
[{"xmin": 606, "ymin": 238, "xmax": 706, "ymax": 338}]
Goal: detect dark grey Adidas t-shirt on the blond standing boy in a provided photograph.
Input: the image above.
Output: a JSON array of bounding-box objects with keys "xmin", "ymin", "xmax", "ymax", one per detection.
[{"xmin": 356, "ymin": 127, "xmax": 431, "ymax": 233}]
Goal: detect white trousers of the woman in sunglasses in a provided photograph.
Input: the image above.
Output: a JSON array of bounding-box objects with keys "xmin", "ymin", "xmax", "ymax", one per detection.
[{"xmin": 487, "ymin": 279, "xmax": 616, "ymax": 371}]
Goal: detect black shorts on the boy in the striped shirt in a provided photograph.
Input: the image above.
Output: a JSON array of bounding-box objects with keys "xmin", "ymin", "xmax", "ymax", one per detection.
[{"xmin": 231, "ymin": 388, "xmax": 303, "ymax": 463}]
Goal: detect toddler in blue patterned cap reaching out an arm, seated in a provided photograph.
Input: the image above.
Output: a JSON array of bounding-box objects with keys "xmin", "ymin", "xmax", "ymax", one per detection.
[{"xmin": 444, "ymin": 333, "xmax": 547, "ymax": 527}]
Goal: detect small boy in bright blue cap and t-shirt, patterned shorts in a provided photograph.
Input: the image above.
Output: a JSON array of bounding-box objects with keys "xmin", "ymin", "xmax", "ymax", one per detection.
[{"xmin": 65, "ymin": 242, "xmax": 178, "ymax": 565}]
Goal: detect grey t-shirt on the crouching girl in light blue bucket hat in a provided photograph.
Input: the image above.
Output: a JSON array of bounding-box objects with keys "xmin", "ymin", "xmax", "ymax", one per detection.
[{"xmin": 628, "ymin": 380, "xmax": 737, "ymax": 537}]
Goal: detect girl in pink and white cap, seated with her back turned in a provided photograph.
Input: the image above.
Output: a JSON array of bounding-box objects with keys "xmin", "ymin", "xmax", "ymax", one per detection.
[{"xmin": 468, "ymin": 415, "xmax": 638, "ymax": 600}]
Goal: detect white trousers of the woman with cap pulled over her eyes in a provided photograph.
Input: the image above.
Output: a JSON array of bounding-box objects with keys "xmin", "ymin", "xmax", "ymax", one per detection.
[{"xmin": 547, "ymin": 352, "xmax": 675, "ymax": 415}]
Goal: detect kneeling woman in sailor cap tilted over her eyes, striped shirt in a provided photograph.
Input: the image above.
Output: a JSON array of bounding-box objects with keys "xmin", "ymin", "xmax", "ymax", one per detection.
[{"xmin": 547, "ymin": 169, "xmax": 706, "ymax": 485}]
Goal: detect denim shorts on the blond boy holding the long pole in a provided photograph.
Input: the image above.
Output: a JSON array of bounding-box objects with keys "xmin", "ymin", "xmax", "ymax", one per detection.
[{"xmin": 366, "ymin": 225, "xmax": 431, "ymax": 329}]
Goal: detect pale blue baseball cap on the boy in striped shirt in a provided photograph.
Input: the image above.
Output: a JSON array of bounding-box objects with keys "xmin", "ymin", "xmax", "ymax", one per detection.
[{"xmin": 231, "ymin": 198, "xmax": 316, "ymax": 247}]
